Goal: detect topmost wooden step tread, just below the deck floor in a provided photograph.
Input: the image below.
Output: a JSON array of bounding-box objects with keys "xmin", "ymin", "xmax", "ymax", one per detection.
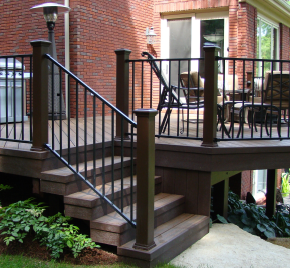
[{"xmin": 41, "ymin": 156, "xmax": 136, "ymax": 182}]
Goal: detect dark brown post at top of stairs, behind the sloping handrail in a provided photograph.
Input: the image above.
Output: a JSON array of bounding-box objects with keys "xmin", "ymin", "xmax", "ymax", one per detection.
[{"xmin": 115, "ymin": 48, "xmax": 131, "ymax": 139}]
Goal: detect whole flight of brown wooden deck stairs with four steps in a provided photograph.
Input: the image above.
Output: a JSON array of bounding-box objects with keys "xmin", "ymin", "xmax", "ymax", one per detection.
[{"xmin": 40, "ymin": 148, "xmax": 209, "ymax": 267}]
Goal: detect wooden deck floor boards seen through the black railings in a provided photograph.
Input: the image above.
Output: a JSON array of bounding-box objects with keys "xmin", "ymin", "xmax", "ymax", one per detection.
[{"xmin": 0, "ymin": 116, "xmax": 290, "ymax": 153}]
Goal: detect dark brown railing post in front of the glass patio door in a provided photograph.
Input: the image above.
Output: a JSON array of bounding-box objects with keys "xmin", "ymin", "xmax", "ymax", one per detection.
[{"xmin": 201, "ymin": 45, "xmax": 219, "ymax": 147}]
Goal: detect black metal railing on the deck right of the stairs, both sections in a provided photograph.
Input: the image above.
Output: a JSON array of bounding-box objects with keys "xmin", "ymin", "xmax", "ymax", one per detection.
[{"xmin": 128, "ymin": 52, "xmax": 290, "ymax": 141}]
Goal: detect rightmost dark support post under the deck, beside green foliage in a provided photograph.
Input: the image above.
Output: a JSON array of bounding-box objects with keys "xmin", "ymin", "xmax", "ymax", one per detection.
[{"xmin": 266, "ymin": 169, "xmax": 277, "ymax": 218}]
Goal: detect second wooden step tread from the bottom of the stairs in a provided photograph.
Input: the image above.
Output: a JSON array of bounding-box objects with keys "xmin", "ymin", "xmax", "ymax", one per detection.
[{"xmin": 91, "ymin": 193, "xmax": 184, "ymax": 233}]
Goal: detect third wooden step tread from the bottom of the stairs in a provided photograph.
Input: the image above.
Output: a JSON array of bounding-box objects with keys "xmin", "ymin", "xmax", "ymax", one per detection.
[{"xmin": 64, "ymin": 175, "xmax": 161, "ymax": 208}]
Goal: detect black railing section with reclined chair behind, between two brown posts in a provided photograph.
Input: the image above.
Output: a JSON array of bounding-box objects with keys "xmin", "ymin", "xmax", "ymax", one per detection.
[{"xmin": 129, "ymin": 56, "xmax": 204, "ymax": 140}]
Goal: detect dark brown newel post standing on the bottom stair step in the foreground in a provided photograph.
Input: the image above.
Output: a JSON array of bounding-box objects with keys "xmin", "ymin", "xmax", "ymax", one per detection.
[{"xmin": 133, "ymin": 109, "xmax": 157, "ymax": 250}]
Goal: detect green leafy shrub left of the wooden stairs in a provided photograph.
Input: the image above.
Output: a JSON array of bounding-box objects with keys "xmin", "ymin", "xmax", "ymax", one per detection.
[{"xmin": 0, "ymin": 198, "xmax": 100, "ymax": 259}]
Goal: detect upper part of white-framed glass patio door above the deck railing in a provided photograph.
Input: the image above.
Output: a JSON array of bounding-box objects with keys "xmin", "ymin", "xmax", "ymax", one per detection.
[{"xmin": 161, "ymin": 12, "xmax": 229, "ymax": 82}]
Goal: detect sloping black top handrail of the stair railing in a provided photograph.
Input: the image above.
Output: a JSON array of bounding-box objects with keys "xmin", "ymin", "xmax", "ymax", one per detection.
[{"xmin": 45, "ymin": 54, "xmax": 137, "ymax": 127}]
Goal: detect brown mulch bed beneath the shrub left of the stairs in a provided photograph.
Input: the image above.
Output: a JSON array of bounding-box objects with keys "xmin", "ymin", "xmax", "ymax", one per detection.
[{"xmin": 0, "ymin": 236, "xmax": 118, "ymax": 265}]
